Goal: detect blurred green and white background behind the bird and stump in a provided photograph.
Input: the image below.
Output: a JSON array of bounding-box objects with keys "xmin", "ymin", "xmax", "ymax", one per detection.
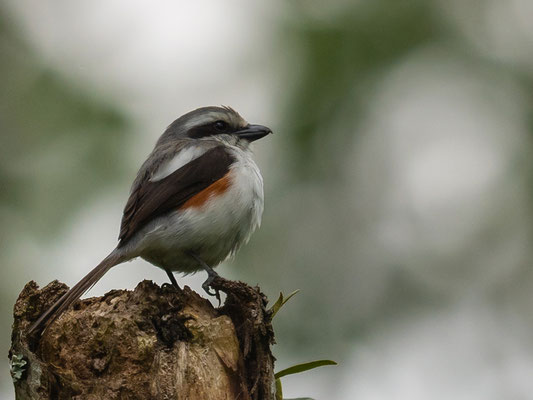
[{"xmin": 0, "ymin": 0, "xmax": 533, "ymax": 400}]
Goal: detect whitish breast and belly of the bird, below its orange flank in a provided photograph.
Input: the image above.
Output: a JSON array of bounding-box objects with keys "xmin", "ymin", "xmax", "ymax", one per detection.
[{"xmin": 133, "ymin": 159, "xmax": 263, "ymax": 273}]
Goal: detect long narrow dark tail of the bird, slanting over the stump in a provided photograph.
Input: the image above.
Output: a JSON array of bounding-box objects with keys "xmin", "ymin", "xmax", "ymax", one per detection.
[{"xmin": 28, "ymin": 249, "xmax": 126, "ymax": 334}]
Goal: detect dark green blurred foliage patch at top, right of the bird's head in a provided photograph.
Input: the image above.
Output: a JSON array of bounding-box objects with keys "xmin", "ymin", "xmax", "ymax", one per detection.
[{"xmin": 280, "ymin": 0, "xmax": 436, "ymax": 179}]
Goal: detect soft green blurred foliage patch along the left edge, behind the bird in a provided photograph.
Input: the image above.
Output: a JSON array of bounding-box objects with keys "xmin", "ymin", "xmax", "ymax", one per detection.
[{"xmin": 0, "ymin": 10, "xmax": 128, "ymax": 238}]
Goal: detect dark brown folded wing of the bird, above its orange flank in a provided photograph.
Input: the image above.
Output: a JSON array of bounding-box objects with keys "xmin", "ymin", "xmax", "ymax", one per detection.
[{"xmin": 118, "ymin": 146, "xmax": 235, "ymax": 247}]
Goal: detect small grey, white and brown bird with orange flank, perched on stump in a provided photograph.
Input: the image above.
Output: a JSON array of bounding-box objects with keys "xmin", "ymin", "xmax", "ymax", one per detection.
[{"xmin": 28, "ymin": 106, "xmax": 272, "ymax": 334}]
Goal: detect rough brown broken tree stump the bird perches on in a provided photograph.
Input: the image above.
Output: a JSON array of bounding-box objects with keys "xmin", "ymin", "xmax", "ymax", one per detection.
[{"xmin": 9, "ymin": 278, "xmax": 274, "ymax": 400}]
